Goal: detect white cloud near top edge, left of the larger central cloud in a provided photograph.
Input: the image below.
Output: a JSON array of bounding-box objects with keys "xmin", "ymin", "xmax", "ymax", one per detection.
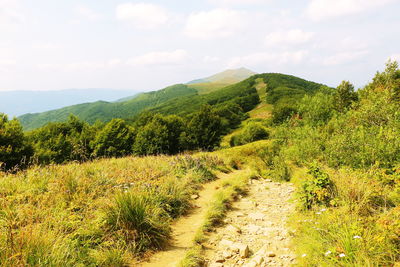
[{"xmin": 116, "ymin": 3, "xmax": 169, "ymax": 29}]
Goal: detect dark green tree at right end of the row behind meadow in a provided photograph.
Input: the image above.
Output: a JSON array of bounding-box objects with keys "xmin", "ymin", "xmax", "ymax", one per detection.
[{"xmin": 187, "ymin": 105, "xmax": 224, "ymax": 150}]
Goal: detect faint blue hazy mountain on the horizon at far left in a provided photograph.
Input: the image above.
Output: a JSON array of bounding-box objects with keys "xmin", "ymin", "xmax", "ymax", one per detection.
[{"xmin": 0, "ymin": 89, "xmax": 135, "ymax": 117}]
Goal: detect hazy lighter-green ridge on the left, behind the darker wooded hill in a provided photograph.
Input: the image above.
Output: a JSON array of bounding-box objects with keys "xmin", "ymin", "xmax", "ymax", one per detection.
[{"xmin": 18, "ymin": 84, "xmax": 197, "ymax": 130}]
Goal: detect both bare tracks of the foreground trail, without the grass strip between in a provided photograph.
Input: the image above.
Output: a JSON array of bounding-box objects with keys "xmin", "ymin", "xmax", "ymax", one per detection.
[{"xmin": 134, "ymin": 172, "xmax": 295, "ymax": 267}]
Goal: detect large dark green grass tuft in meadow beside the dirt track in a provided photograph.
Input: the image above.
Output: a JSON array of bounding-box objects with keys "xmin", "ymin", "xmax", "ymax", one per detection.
[{"xmin": 106, "ymin": 192, "xmax": 170, "ymax": 252}]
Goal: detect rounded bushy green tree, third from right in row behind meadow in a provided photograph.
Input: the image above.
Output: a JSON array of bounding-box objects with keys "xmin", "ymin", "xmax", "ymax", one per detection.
[{"xmin": 93, "ymin": 119, "xmax": 134, "ymax": 157}]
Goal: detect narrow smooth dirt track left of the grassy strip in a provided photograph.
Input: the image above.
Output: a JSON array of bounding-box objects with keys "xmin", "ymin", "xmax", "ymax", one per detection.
[{"xmin": 135, "ymin": 172, "xmax": 241, "ymax": 267}]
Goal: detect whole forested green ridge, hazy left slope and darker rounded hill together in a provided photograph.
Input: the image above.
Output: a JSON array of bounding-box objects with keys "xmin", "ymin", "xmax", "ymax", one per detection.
[{"xmin": 18, "ymin": 73, "xmax": 322, "ymax": 130}]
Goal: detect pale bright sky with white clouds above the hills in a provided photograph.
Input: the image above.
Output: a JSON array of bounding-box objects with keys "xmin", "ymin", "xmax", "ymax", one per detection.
[{"xmin": 0, "ymin": 0, "xmax": 400, "ymax": 91}]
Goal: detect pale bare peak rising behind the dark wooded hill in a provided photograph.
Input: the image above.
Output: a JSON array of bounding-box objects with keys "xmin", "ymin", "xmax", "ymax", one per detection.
[{"xmin": 187, "ymin": 68, "xmax": 256, "ymax": 84}]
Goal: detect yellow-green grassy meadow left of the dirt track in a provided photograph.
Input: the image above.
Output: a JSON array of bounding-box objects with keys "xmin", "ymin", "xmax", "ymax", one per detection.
[{"xmin": 0, "ymin": 155, "xmax": 224, "ymax": 266}]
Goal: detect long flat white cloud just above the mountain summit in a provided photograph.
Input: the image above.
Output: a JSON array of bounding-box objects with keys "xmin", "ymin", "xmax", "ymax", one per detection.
[{"xmin": 228, "ymin": 50, "xmax": 308, "ymax": 68}]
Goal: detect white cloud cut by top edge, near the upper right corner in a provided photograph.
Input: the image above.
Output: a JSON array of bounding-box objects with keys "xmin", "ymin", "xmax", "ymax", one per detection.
[{"xmin": 306, "ymin": 0, "xmax": 397, "ymax": 21}]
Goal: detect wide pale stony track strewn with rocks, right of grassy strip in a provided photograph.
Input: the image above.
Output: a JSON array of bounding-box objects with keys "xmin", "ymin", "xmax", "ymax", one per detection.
[{"xmin": 205, "ymin": 179, "xmax": 295, "ymax": 267}]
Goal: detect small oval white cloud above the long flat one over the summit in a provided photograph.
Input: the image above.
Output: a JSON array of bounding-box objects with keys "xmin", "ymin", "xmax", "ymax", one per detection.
[{"xmin": 265, "ymin": 29, "xmax": 314, "ymax": 46}]
